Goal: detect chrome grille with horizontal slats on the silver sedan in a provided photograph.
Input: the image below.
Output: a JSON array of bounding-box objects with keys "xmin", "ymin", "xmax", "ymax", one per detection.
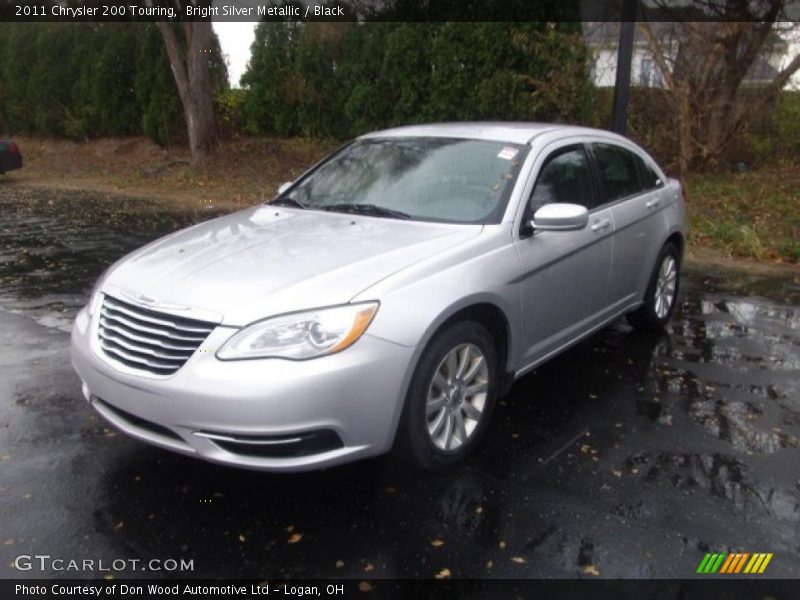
[{"xmin": 98, "ymin": 295, "xmax": 214, "ymax": 375}]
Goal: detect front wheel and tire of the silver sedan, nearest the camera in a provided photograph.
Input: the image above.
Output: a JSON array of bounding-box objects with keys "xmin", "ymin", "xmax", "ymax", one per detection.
[{"xmin": 395, "ymin": 321, "xmax": 500, "ymax": 471}]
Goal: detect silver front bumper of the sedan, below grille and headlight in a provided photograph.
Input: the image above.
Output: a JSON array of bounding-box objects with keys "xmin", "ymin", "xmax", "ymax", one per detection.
[{"xmin": 71, "ymin": 309, "xmax": 414, "ymax": 471}]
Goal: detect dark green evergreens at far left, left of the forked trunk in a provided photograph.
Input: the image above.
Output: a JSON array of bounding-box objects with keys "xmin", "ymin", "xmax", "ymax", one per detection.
[{"xmin": 0, "ymin": 22, "xmax": 228, "ymax": 144}]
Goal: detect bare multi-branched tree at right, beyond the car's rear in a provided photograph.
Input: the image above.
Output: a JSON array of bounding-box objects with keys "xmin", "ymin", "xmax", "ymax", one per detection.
[{"xmin": 638, "ymin": 0, "xmax": 800, "ymax": 173}]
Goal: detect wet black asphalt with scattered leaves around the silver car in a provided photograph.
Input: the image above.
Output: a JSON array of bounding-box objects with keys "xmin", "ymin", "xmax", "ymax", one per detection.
[{"xmin": 0, "ymin": 182, "xmax": 800, "ymax": 579}]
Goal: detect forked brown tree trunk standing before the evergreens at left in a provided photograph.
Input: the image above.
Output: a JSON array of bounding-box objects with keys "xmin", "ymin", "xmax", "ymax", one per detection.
[{"xmin": 158, "ymin": 21, "xmax": 218, "ymax": 167}]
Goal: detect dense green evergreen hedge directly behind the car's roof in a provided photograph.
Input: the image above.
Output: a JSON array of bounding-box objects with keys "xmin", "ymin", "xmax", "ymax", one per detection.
[{"xmin": 242, "ymin": 22, "xmax": 591, "ymax": 138}]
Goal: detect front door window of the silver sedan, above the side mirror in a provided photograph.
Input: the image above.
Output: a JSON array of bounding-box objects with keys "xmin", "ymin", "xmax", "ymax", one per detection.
[{"xmin": 528, "ymin": 145, "xmax": 595, "ymax": 215}]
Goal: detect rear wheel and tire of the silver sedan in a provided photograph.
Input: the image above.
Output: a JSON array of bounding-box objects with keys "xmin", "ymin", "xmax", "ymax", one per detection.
[{"xmin": 628, "ymin": 242, "xmax": 681, "ymax": 331}]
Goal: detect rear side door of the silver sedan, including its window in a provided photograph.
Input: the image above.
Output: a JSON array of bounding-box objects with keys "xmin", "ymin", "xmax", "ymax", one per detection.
[{"xmin": 590, "ymin": 142, "xmax": 665, "ymax": 310}]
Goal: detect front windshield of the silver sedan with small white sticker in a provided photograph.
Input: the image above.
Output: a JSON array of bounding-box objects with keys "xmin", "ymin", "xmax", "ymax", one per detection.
[{"xmin": 275, "ymin": 137, "xmax": 526, "ymax": 223}]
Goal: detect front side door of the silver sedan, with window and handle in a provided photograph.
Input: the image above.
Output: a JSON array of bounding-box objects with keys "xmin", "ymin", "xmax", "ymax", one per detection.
[{"xmin": 516, "ymin": 144, "xmax": 614, "ymax": 366}]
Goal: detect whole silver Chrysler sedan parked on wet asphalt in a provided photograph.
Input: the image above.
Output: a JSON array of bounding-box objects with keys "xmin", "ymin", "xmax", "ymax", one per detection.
[{"xmin": 72, "ymin": 123, "xmax": 684, "ymax": 470}]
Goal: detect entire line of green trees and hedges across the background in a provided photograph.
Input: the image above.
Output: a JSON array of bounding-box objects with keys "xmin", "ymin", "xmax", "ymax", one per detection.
[{"xmin": 0, "ymin": 22, "xmax": 800, "ymax": 167}]
